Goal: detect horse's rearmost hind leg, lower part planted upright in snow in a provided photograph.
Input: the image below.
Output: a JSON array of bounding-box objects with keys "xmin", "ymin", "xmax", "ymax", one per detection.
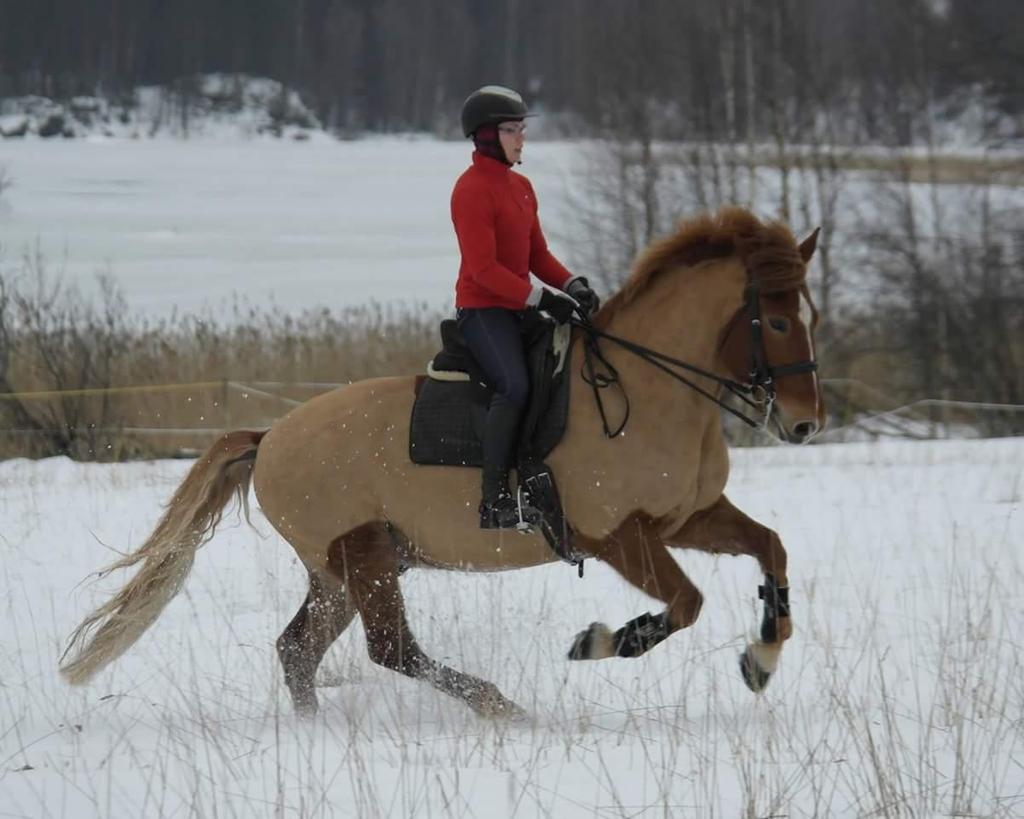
[{"xmin": 278, "ymin": 572, "xmax": 355, "ymax": 716}]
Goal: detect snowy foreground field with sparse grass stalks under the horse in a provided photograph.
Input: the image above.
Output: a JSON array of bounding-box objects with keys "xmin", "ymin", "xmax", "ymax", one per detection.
[{"xmin": 0, "ymin": 439, "xmax": 1024, "ymax": 819}]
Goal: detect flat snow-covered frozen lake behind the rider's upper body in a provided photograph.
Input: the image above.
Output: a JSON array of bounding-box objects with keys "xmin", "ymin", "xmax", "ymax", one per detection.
[{"xmin": 0, "ymin": 139, "xmax": 571, "ymax": 315}]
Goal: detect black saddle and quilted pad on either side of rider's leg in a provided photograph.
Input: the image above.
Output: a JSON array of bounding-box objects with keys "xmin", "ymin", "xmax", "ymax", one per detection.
[{"xmin": 409, "ymin": 319, "xmax": 570, "ymax": 467}]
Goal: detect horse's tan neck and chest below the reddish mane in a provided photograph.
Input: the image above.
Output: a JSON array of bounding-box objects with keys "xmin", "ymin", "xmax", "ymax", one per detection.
[{"xmin": 565, "ymin": 260, "xmax": 745, "ymax": 507}]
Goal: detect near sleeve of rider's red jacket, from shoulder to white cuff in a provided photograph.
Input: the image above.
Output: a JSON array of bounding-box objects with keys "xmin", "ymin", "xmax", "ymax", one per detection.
[{"xmin": 452, "ymin": 185, "xmax": 543, "ymax": 304}]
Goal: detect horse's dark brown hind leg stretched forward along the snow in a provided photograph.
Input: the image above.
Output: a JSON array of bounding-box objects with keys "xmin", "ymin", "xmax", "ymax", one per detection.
[{"xmin": 329, "ymin": 523, "xmax": 523, "ymax": 717}]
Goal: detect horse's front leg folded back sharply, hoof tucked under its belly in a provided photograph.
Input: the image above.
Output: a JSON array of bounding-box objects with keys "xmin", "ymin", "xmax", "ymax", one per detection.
[{"xmin": 568, "ymin": 515, "xmax": 703, "ymax": 659}]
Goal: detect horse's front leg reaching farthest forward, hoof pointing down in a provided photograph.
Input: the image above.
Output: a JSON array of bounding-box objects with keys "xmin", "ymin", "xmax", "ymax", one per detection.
[{"xmin": 671, "ymin": 494, "xmax": 793, "ymax": 692}]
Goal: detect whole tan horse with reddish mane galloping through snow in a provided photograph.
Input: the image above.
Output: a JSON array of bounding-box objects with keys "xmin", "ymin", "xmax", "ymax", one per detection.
[{"xmin": 61, "ymin": 209, "xmax": 824, "ymax": 715}]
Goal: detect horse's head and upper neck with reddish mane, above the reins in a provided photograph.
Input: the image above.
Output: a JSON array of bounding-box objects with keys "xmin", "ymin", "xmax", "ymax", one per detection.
[{"xmin": 594, "ymin": 208, "xmax": 825, "ymax": 443}]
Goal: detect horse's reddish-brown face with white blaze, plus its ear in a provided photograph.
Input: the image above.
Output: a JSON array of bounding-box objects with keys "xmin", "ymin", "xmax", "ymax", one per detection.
[{"xmin": 721, "ymin": 230, "xmax": 825, "ymax": 443}]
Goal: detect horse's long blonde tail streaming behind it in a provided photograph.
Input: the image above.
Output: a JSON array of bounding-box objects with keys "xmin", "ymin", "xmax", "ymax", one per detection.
[{"xmin": 60, "ymin": 431, "xmax": 264, "ymax": 685}]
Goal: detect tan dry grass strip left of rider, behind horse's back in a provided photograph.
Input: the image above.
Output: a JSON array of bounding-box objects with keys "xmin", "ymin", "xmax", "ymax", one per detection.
[{"xmin": 0, "ymin": 292, "xmax": 443, "ymax": 460}]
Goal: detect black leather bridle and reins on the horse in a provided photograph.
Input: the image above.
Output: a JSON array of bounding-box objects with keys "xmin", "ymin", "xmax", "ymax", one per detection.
[{"xmin": 572, "ymin": 284, "xmax": 818, "ymax": 438}]
